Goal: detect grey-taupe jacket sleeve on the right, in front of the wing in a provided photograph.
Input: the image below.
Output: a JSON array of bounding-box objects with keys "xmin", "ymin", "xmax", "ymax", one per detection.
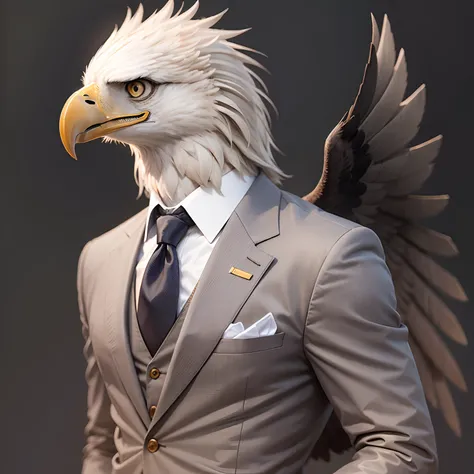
[{"xmin": 304, "ymin": 227, "xmax": 438, "ymax": 474}]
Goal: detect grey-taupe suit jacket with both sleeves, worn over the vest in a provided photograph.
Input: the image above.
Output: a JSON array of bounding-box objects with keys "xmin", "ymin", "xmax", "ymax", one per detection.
[{"xmin": 78, "ymin": 173, "xmax": 437, "ymax": 474}]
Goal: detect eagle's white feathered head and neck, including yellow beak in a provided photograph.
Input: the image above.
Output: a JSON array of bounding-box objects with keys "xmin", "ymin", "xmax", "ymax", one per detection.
[{"xmin": 60, "ymin": 0, "xmax": 286, "ymax": 204}]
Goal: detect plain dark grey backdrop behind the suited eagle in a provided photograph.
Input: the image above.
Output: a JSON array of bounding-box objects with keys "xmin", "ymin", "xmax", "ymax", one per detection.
[{"xmin": 0, "ymin": 0, "xmax": 474, "ymax": 474}]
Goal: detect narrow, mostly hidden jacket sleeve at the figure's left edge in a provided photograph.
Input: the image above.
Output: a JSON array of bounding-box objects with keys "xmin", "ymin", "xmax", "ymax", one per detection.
[{"xmin": 77, "ymin": 242, "xmax": 116, "ymax": 474}]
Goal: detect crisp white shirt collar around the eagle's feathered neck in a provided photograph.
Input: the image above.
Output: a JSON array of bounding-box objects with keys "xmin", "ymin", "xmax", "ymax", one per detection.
[{"xmin": 145, "ymin": 170, "xmax": 255, "ymax": 243}]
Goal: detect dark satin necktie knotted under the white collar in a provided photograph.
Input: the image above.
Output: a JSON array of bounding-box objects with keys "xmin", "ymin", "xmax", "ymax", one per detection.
[{"xmin": 137, "ymin": 206, "xmax": 194, "ymax": 355}]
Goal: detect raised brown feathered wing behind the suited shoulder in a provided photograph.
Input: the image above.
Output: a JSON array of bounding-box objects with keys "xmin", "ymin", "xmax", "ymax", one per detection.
[{"xmin": 304, "ymin": 16, "xmax": 467, "ymax": 459}]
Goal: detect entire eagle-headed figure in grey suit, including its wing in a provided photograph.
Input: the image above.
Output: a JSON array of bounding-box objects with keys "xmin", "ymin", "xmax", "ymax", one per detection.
[{"xmin": 60, "ymin": 0, "xmax": 467, "ymax": 474}]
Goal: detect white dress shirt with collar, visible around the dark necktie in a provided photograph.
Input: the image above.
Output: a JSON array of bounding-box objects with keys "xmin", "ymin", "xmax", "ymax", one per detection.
[{"xmin": 135, "ymin": 170, "xmax": 255, "ymax": 313}]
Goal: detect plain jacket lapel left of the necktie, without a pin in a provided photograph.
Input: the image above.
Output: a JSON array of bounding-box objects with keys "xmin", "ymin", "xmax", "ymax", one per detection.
[{"xmin": 105, "ymin": 209, "xmax": 148, "ymax": 425}]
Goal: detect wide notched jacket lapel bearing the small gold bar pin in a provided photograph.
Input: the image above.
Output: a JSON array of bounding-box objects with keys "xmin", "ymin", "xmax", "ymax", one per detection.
[{"xmin": 151, "ymin": 174, "xmax": 281, "ymax": 428}]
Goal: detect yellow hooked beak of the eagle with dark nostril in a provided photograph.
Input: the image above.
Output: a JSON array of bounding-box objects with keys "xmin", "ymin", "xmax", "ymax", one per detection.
[{"xmin": 59, "ymin": 84, "xmax": 150, "ymax": 159}]
